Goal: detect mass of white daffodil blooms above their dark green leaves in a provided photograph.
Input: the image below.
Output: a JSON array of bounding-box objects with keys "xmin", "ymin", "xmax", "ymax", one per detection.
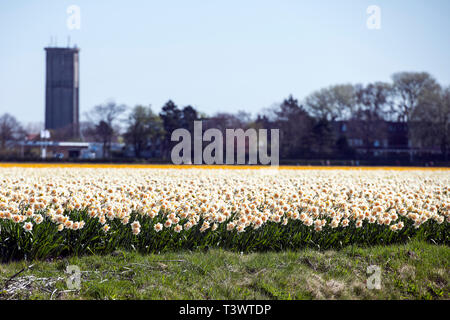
[{"xmin": 0, "ymin": 168, "xmax": 450, "ymax": 235}]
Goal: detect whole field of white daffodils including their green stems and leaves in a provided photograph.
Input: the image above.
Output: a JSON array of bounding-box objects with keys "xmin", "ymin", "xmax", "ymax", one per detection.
[{"xmin": 0, "ymin": 167, "xmax": 450, "ymax": 260}]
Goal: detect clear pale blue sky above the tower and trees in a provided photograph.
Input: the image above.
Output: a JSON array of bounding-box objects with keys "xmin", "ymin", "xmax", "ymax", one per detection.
[{"xmin": 0, "ymin": 0, "xmax": 450, "ymax": 124}]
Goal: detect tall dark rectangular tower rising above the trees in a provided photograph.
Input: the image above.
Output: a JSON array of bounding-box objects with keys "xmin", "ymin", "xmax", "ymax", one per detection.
[{"xmin": 45, "ymin": 47, "xmax": 80, "ymax": 137}]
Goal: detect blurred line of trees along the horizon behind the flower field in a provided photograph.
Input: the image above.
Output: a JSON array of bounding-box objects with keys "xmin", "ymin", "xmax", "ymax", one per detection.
[{"xmin": 0, "ymin": 72, "xmax": 450, "ymax": 161}]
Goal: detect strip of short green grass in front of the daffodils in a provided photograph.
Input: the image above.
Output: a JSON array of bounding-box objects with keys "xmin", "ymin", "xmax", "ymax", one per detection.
[{"xmin": 0, "ymin": 241, "xmax": 450, "ymax": 299}]
